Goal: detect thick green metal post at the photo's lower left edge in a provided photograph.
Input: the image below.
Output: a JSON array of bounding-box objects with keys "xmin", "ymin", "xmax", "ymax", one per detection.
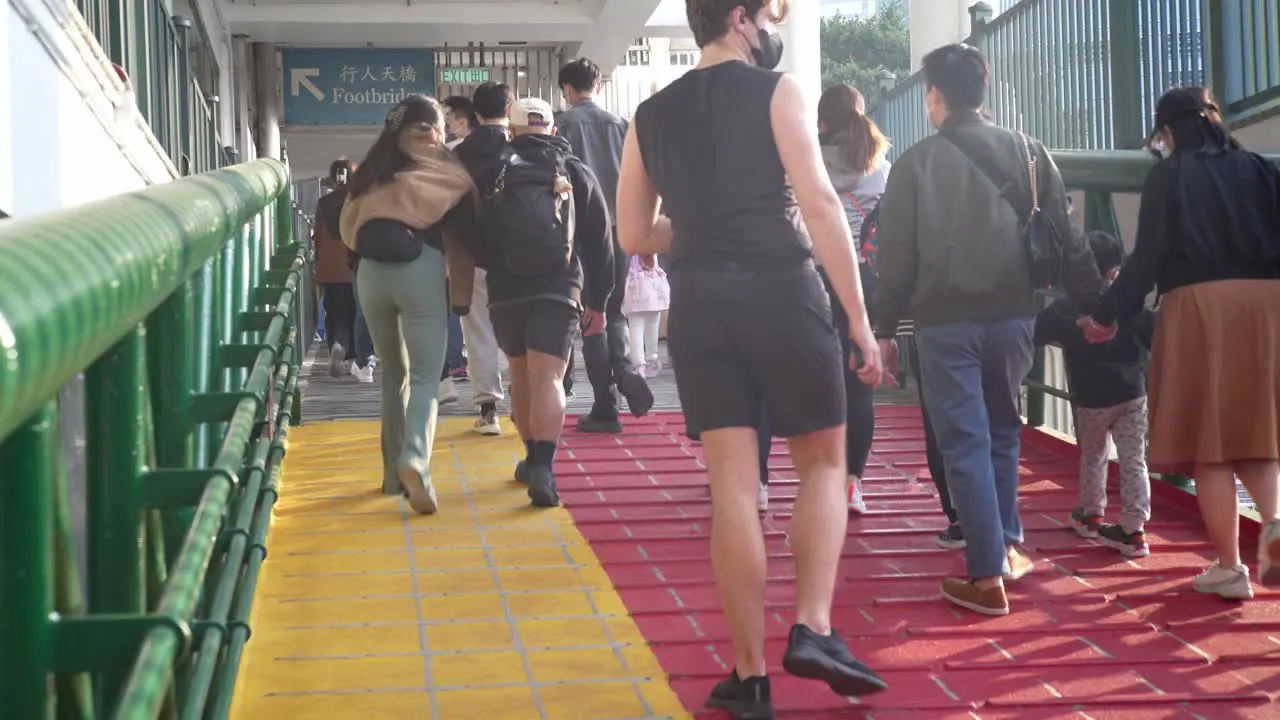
[{"xmin": 0, "ymin": 401, "xmax": 58, "ymax": 720}]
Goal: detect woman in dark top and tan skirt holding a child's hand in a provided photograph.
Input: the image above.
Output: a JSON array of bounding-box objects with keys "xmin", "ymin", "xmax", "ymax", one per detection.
[{"xmin": 1080, "ymin": 87, "xmax": 1280, "ymax": 600}]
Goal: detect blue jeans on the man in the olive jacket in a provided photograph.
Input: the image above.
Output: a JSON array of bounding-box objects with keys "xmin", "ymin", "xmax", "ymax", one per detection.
[{"xmin": 915, "ymin": 318, "xmax": 1036, "ymax": 579}]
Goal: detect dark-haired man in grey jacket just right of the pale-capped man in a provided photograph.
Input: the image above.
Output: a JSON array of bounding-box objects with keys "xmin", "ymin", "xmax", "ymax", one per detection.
[{"xmin": 556, "ymin": 58, "xmax": 653, "ymax": 425}]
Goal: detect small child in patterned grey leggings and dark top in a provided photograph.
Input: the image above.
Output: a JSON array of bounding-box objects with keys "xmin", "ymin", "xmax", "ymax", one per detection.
[{"xmin": 1036, "ymin": 232, "xmax": 1156, "ymax": 557}]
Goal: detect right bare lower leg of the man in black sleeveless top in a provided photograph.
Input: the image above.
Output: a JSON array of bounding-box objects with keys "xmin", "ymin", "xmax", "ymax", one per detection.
[{"xmin": 787, "ymin": 425, "xmax": 849, "ymax": 635}]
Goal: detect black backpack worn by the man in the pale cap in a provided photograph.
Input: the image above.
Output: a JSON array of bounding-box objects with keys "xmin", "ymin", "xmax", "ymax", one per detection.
[{"xmin": 480, "ymin": 150, "xmax": 575, "ymax": 277}]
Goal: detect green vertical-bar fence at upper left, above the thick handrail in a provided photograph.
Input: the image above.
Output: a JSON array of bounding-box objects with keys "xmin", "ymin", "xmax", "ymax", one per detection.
[{"xmin": 76, "ymin": 0, "xmax": 224, "ymax": 174}]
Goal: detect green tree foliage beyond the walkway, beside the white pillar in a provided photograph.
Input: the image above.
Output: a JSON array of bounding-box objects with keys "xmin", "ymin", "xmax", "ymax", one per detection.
[{"xmin": 822, "ymin": 0, "xmax": 911, "ymax": 102}]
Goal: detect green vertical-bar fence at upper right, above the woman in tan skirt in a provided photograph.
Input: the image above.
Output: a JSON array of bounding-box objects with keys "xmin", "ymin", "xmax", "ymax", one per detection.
[{"xmin": 873, "ymin": 0, "xmax": 1280, "ymax": 156}]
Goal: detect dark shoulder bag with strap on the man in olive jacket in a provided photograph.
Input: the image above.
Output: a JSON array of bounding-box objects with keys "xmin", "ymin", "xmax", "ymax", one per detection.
[{"xmin": 941, "ymin": 132, "xmax": 1065, "ymax": 290}]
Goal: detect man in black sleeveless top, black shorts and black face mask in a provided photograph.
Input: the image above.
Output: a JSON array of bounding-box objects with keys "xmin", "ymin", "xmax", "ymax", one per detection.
[{"xmin": 617, "ymin": 0, "xmax": 886, "ymax": 720}]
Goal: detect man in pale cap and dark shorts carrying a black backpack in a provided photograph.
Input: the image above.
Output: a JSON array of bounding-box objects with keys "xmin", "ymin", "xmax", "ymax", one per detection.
[{"xmin": 478, "ymin": 97, "xmax": 614, "ymax": 507}]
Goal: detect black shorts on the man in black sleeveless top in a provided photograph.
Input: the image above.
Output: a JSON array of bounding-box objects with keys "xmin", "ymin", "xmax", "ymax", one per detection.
[{"xmin": 667, "ymin": 264, "xmax": 847, "ymax": 437}]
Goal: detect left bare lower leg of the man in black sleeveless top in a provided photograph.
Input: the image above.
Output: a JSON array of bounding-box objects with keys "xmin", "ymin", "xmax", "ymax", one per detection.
[{"xmin": 701, "ymin": 428, "xmax": 765, "ymax": 678}]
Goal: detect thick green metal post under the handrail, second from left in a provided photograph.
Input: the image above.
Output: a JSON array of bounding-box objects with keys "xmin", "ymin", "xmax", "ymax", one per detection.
[{"xmin": 84, "ymin": 327, "xmax": 147, "ymax": 707}]
